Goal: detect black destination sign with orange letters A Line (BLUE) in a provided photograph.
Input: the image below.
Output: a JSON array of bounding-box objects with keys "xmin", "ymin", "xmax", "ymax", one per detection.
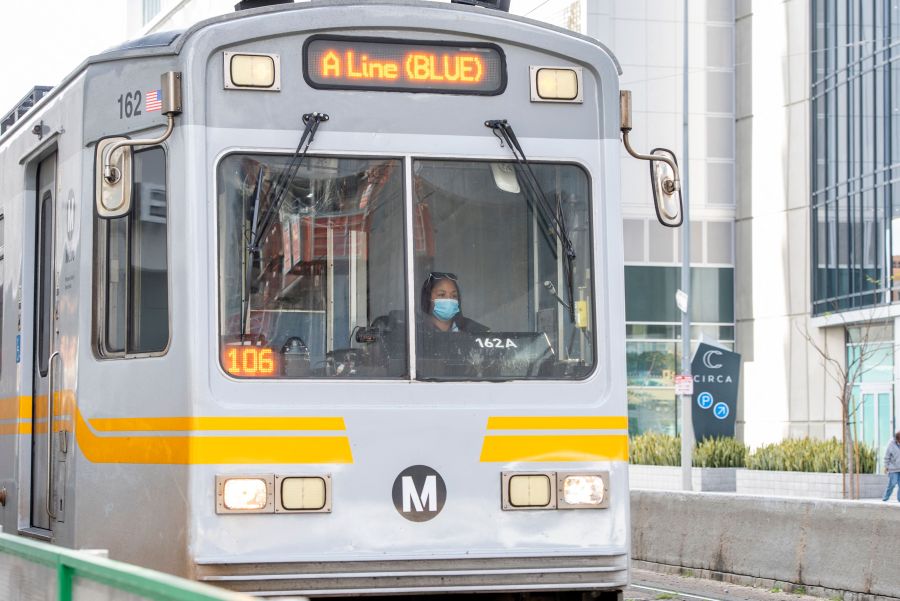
[{"xmin": 303, "ymin": 36, "xmax": 506, "ymax": 95}]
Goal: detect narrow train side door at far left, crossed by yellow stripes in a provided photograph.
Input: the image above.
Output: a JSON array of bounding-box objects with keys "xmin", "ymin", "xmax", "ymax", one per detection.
[{"xmin": 31, "ymin": 153, "xmax": 62, "ymax": 531}]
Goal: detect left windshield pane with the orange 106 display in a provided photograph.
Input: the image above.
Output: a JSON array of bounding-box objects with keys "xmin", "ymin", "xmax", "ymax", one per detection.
[{"xmin": 218, "ymin": 155, "xmax": 407, "ymax": 377}]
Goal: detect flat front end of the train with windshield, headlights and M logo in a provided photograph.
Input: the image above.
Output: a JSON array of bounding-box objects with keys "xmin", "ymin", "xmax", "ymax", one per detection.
[{"xmin": 187, "ymin": 1, "xmax": 629, "ymax": 596}]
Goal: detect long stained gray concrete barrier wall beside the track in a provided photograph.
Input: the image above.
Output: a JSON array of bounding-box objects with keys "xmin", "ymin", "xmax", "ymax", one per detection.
[{"xmin": 631, "ymin": 491, "xmax": 900, "ymax": 601}]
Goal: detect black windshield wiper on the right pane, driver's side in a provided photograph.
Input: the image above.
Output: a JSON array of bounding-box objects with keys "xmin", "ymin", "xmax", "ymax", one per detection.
[{"xmin": 484, "ymin": 119, "xmax": 575, "ymax": 323}]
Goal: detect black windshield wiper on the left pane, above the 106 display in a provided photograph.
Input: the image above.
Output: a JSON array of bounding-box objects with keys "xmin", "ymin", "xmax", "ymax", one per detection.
[{"xmin": 241, "ymin": 113, "xmax": 330, "ymax": 341}]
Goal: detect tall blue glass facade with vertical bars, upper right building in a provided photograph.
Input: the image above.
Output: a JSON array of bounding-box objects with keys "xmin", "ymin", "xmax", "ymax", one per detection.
[{"xmin": 811, "ymin": 0, "xmax": 900, "ymax": 315}]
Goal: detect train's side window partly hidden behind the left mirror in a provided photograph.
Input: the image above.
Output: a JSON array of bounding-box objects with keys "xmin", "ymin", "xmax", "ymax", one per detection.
[{"xmin": 97, "ymin": 147, "xmax": 169, "ymax": 357}]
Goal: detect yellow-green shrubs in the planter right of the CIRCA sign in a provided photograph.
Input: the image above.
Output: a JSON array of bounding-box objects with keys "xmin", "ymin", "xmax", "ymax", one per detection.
[{"xmin": 747, "ymin": 438, "xmax": 876, "ymax": 474}]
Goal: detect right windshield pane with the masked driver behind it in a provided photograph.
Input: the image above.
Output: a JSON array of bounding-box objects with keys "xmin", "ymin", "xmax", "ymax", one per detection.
[{"xmin": 413, "ymin": 161, "xmax": 594, "ymax": 379}]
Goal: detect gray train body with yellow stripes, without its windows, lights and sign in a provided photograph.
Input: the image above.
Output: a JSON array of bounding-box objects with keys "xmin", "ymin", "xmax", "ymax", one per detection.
[{"xmin": 0, "ymin": 0, "xmax": 629, "ymax": 595}]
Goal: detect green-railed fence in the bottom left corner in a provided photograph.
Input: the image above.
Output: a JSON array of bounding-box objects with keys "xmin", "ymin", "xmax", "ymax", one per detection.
[{"xmin": 0, "ymin": 533, "xmax": 250, "ymax": 601}]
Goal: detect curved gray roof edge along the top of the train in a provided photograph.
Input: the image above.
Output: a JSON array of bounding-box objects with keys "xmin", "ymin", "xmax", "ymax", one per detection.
[{"xmin": 0, "ymin": 0, "xmax": 622, "ymax": 138}]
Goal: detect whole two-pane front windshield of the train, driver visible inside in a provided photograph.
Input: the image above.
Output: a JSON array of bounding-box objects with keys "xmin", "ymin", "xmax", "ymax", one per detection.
[{"xmin": 217, "ymin": 154, "xmax": 594, "ymax": 380}]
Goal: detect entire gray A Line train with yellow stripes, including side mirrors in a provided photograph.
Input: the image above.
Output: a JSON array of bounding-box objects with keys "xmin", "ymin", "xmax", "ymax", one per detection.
[{"xmin": 0, "ymin": 0, "xmax": 681, "ymax": 598}]
